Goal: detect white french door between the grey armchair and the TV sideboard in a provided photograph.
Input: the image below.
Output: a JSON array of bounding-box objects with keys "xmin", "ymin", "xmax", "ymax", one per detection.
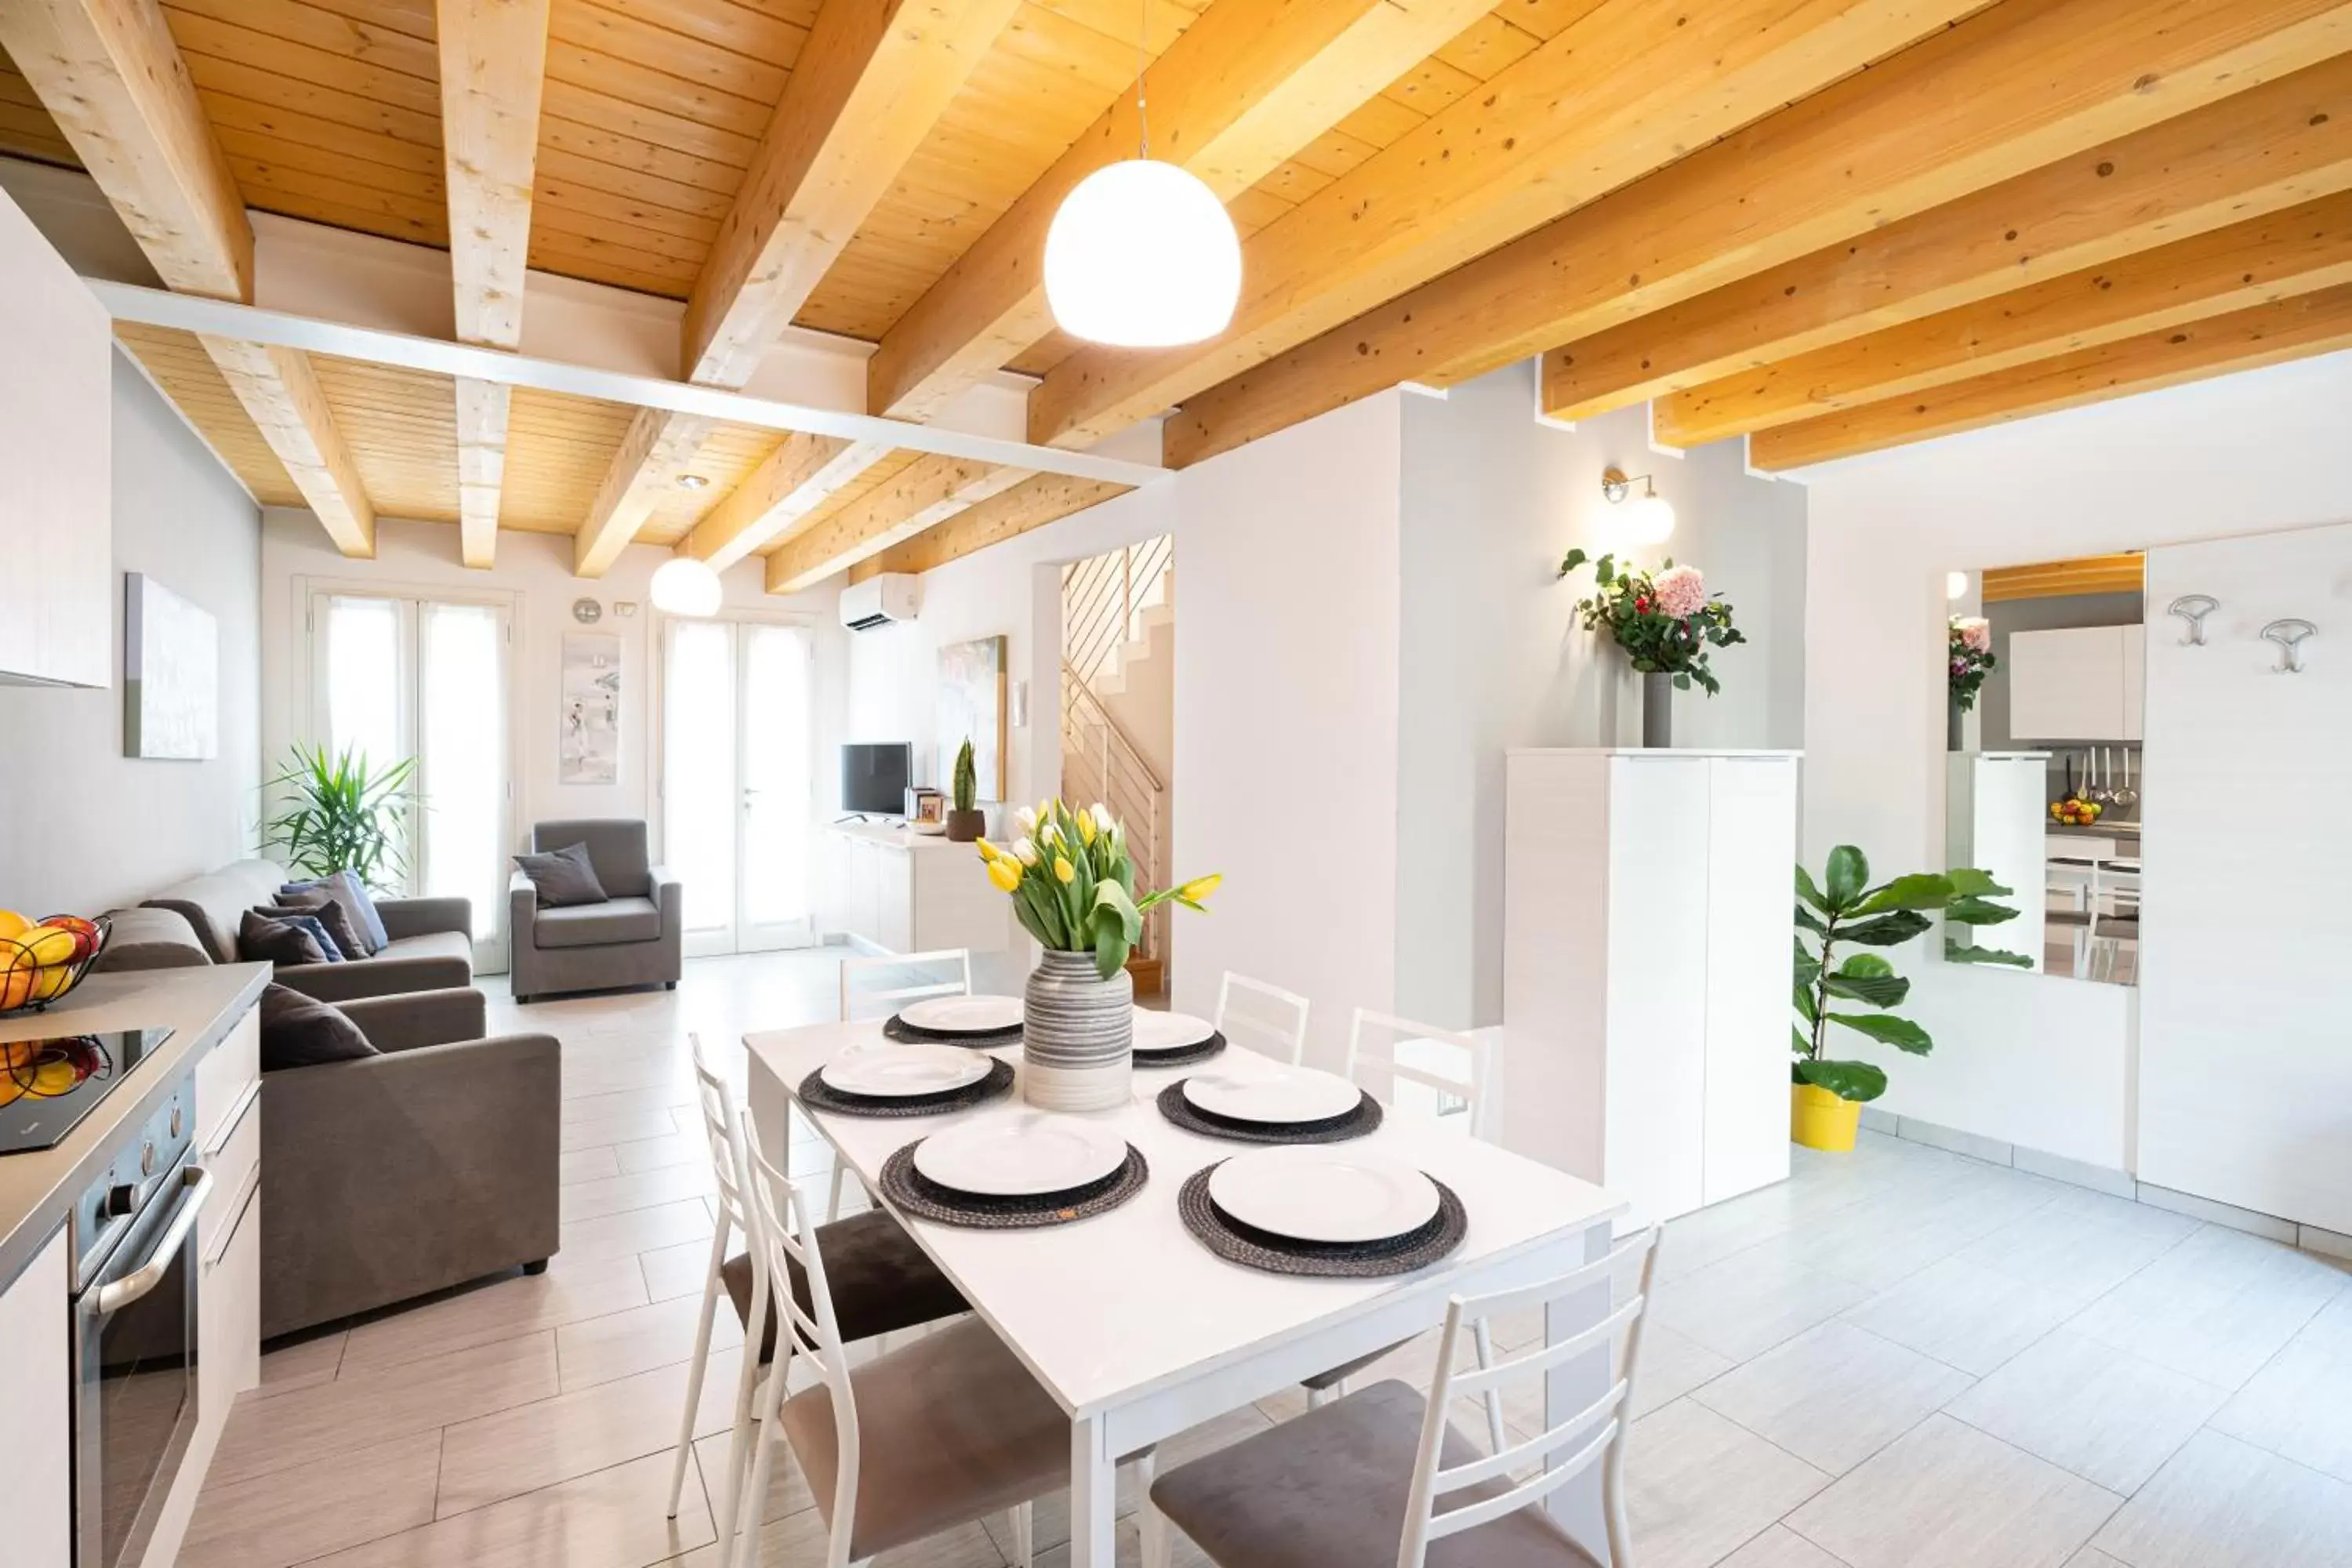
[{"xmin": 661, "ymin": 619, "xmax": 816, "ymax": 954}]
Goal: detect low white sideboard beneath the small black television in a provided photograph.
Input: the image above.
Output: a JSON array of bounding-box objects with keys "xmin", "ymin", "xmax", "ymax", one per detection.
[{"xmin": 818, "ymin": 822, "xmax": 1011, "ymax": 952}]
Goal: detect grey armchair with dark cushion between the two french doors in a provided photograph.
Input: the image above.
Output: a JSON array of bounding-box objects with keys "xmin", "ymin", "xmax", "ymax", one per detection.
[{"xmin": 506, "ymin": 818, "xmax": 687, "ymax": 1001}]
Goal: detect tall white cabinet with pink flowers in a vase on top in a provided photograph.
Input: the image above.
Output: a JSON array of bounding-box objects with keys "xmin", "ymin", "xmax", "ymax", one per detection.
[{"xmin": 1503, "ymin": 750, "xmax": 1799, "ymax": 1222}]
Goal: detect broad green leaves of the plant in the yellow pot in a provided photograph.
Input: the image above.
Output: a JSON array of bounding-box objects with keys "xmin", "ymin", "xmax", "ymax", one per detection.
[{"xmin": 1790, "ymin": 844, "xmax": 2025, "ymax": 1100}]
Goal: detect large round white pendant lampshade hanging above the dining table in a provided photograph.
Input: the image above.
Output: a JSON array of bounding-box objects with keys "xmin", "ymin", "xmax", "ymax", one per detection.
[{"xmin": 1044, "ymin": 158, "xmax": 1242, "ymax": 348}]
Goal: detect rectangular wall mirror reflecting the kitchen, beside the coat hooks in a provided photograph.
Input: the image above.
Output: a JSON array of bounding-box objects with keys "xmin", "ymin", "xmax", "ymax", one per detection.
[{"xmin": 1943, "ymin": 555, "xmax": 2161, "ymax": 985}]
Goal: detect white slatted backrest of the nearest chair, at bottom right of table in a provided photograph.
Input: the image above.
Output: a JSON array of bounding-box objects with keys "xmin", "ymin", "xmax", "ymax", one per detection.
[{"xmin": 1397, "ymin": 1225, "xmax": 1658, "ymax": 1568}]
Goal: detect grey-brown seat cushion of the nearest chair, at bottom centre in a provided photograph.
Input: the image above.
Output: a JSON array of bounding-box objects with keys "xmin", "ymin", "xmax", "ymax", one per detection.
[{"xmin": 1152, "ymin": 1380, "xmax": 1595, "ymax": 1568}]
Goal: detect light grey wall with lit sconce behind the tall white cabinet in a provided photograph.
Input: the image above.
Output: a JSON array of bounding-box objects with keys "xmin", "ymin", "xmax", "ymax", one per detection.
[{"xmin": 1383, "ymin": 362, "xmax": 1806, "ymax": 1027}]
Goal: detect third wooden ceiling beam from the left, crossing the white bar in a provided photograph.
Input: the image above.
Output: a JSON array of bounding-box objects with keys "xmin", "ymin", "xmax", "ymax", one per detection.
[{"xmin": 572, "ymin": 0, "xmax": 1021, "ymax": 576}]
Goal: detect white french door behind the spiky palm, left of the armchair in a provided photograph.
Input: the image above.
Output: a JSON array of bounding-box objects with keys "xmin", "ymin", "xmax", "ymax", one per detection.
[{"xmin": 310, "ymin": 590, "xmax": 513, "ymax": 971}]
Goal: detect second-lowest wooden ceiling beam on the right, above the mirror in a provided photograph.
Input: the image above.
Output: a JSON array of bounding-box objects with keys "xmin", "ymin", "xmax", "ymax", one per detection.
[{"xmin": 1656, "ymin": 193, "xmax": 2352, "ymax": 447}]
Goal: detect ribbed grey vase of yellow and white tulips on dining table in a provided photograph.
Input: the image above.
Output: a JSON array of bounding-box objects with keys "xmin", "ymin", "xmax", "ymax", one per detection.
[{"xmin": 981, "ymin": 799, "xmax": 1221, "ymax": 1109}]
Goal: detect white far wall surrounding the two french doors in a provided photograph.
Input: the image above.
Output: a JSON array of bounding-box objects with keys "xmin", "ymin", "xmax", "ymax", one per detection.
[{"xmin": 261, "ymin": 508, "xmax": 849, "ymax": 884}]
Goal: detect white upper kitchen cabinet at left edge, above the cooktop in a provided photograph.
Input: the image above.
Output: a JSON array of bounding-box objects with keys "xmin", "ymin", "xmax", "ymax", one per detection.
[{"xmin": 0, "ymin": 193, "xmax": 115, "ymax": 687}]
